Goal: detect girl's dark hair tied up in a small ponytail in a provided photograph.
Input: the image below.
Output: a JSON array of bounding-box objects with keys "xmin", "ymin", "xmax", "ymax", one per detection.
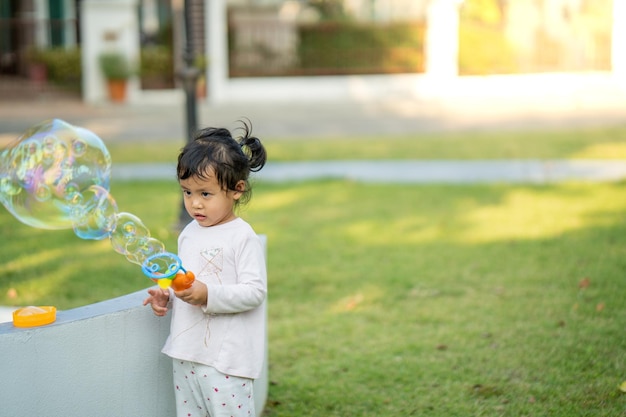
[{"xmin": 176, "ymin": 121, "xmax": 267, "ymax": 204}]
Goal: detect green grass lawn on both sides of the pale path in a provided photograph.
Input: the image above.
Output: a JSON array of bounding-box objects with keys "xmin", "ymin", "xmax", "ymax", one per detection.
[{"xmin": 0, "ymin": 128, "xmax": 626, "ymax": 417}]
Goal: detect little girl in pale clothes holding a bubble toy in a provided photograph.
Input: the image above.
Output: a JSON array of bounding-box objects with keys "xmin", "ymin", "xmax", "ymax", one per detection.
[{"xmin": 144, "ymin": 123, "xmax": 267, "ymax": 417}]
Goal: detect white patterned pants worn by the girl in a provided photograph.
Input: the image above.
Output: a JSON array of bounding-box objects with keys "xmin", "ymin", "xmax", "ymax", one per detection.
[{"xmin": 173, "ymin": 359, "xmax": 255, "ymax": 417}]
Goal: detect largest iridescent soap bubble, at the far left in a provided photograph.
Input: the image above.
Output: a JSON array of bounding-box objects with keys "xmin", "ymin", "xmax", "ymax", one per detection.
[{"xmin": 0, "ymin": 119, "xmax": 111, "ymax": 229}]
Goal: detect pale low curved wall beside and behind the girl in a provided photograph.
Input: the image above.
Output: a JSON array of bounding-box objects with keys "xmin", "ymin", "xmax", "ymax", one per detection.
[{"xmin": 0, "ymin": 240, "xmax": 268, "ymax": 417}]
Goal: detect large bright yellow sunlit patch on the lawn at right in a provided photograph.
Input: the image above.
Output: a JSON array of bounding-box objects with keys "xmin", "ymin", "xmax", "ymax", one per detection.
[{"xmin": 332, "ymin": 184, "xmax": 626, "ymax": 245}]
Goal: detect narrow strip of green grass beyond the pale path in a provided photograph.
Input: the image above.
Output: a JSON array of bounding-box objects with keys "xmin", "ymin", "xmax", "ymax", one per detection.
[{"xmin": 107, "ymin": 125, "xmax": 626, "ymax": 163}]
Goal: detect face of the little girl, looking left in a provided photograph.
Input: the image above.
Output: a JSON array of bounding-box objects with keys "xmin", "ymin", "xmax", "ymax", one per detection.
[{"xmin": 179, "ymin": 170, "xmax": 245, "ymax": 227}]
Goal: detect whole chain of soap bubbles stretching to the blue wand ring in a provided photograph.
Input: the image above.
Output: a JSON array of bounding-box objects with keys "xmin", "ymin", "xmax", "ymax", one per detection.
[{"xmin": 0, "ymin": 119, "xmax": 184, "ymax": 279}]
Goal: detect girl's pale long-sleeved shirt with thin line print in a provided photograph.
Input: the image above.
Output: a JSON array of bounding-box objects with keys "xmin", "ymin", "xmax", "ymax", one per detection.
[{"xmin": 163, "ymin": 218, "xmax": 267, "ymax": 379}]
